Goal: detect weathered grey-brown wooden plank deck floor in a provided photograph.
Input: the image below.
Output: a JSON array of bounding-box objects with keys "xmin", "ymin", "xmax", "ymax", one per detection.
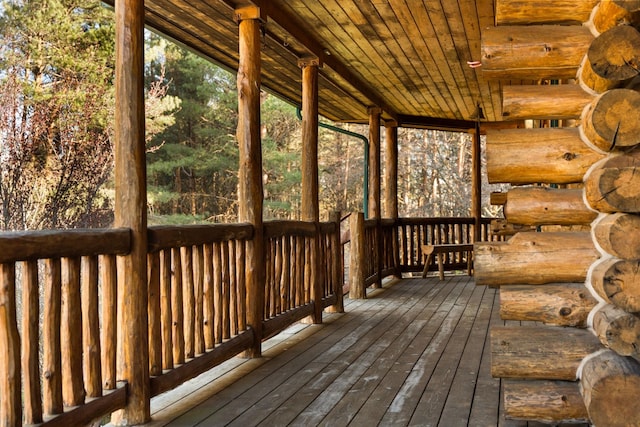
[{"xmin": 152, "ymin": 276, "xmax": 572, "ymax": 427}]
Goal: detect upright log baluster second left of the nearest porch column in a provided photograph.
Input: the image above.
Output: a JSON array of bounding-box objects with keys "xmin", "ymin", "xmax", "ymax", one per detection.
[{"xmin": 81, "ymin": 256, "xmax": 102, "ymax": 397}]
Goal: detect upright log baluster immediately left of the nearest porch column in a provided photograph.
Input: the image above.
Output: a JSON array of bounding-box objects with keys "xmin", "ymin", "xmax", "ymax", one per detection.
[{"xmin": 100, "ymin": 255, "xmax": 118, "ymax": 390}]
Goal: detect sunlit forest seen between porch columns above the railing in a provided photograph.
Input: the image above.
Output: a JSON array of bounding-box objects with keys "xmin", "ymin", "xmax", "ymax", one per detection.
[{"xmin": 0, "ymin": 0, "xmax": 496, "ymax": 230}]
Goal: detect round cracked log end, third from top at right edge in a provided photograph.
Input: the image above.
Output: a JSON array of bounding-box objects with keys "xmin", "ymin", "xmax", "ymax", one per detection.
[{"xmin": 582, "ymin": 89, "xmax": 640, "ymax": 152}]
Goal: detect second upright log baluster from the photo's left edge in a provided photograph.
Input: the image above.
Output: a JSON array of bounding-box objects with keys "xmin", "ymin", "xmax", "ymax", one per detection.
[{"xmin": 21, "ymin": 261, "xmax": 42, "ymax": 424}]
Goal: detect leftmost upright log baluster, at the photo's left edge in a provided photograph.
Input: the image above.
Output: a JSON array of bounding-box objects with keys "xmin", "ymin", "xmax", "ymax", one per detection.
[{"xmin": 0, "ymin": 263, "xmax": 22, "ymax": 426}]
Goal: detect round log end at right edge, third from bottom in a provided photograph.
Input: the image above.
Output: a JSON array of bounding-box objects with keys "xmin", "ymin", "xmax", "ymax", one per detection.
[{"xmin": 591, "ymin": 258, "xmax": 640, "ymax": 313}]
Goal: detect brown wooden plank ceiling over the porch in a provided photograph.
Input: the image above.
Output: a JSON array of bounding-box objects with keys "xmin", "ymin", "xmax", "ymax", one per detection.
[{"xmin": 127, "ymin": 0, "xmax": 501, "ymax": 128}]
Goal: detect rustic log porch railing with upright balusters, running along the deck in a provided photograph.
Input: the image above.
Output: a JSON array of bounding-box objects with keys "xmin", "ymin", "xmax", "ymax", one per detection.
[{"xmin": 0, "ymin": 217, "xmax": 491, "ymax": 425}]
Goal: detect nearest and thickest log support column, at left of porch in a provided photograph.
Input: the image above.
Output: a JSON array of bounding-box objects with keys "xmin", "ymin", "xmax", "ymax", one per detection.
[{"xmin": 113, "ymin": 0, "xmax": 151, "ymax": 425}]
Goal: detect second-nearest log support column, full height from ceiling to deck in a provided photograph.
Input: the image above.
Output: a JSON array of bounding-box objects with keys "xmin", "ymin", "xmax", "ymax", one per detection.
[{"xmin": 235, "ymin": 6, "xmax": 265, "ymax": 357}]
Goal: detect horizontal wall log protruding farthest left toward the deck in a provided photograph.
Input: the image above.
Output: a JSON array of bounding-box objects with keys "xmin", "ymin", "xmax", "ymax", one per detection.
[{"xmin": 474, "ymin": 232, "xmax": 599, "ymax": 286}]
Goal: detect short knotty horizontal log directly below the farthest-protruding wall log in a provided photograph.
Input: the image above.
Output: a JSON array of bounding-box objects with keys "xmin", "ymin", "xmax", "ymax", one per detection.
[{"xmin": 500, "ymin": 283, "xmax": 597, "ymax": 328}]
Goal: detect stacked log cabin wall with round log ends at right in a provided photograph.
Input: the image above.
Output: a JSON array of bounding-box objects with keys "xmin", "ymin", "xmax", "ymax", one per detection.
[{"xmin": 474, "ymin": 0, "xmax": 640, "ymax": 426}]
